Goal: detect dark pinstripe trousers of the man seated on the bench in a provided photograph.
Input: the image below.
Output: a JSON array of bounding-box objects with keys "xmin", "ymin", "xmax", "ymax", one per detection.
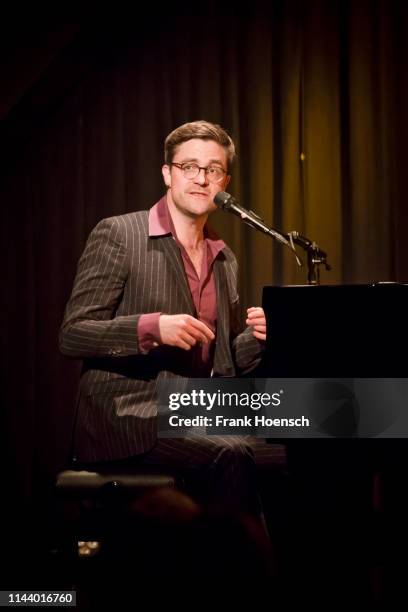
[{"xmin": 74, "ymin": 433, "xmax": 286, "ymax": 521}]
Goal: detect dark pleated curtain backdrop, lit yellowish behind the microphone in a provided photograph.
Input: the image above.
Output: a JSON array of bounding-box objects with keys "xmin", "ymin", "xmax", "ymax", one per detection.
[{"xmin": 0, "ymin": 0, "xmax": 408, "ymax": 524}]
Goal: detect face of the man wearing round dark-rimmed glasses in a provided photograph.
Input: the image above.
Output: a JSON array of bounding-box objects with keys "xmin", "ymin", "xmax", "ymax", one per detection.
[{"xmin": 162, "ymin": 138, "xmax": 231, "ymax": 218}]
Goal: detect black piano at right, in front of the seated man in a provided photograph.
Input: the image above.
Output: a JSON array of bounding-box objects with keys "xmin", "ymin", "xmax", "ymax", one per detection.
[{"xmin": 258, "ymin": 282, "xmax": 408, "ymax": 514}]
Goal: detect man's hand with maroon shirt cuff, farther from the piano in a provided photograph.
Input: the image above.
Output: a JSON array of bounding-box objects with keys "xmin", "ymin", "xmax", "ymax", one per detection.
[{"xmin": 159, "ymin": 314, "xmax": 215, "ymax": 351}]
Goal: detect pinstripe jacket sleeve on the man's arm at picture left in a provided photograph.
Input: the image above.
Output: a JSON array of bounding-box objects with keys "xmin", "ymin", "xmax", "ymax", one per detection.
[{"xmin": 59, "ymin": 217, "xmax": 145, "ymax": 359}]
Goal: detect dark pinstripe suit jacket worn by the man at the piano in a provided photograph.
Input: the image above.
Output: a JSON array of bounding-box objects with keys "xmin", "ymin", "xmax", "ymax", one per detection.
[{"xmin": 60, "ymin": 203, "xmax": 260, "ymax": 461}]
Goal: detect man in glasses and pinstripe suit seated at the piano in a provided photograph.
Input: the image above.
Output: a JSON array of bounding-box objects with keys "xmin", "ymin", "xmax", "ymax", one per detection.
[{"xmin": 60, "ymin": 121, "xmax": 266, "ymax": 513}]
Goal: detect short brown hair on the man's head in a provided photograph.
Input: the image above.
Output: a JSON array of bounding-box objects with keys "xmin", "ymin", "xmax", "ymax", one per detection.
[{"xmin": 164, "ymin": 121, "xmax": 236, "ymax": 171}]
